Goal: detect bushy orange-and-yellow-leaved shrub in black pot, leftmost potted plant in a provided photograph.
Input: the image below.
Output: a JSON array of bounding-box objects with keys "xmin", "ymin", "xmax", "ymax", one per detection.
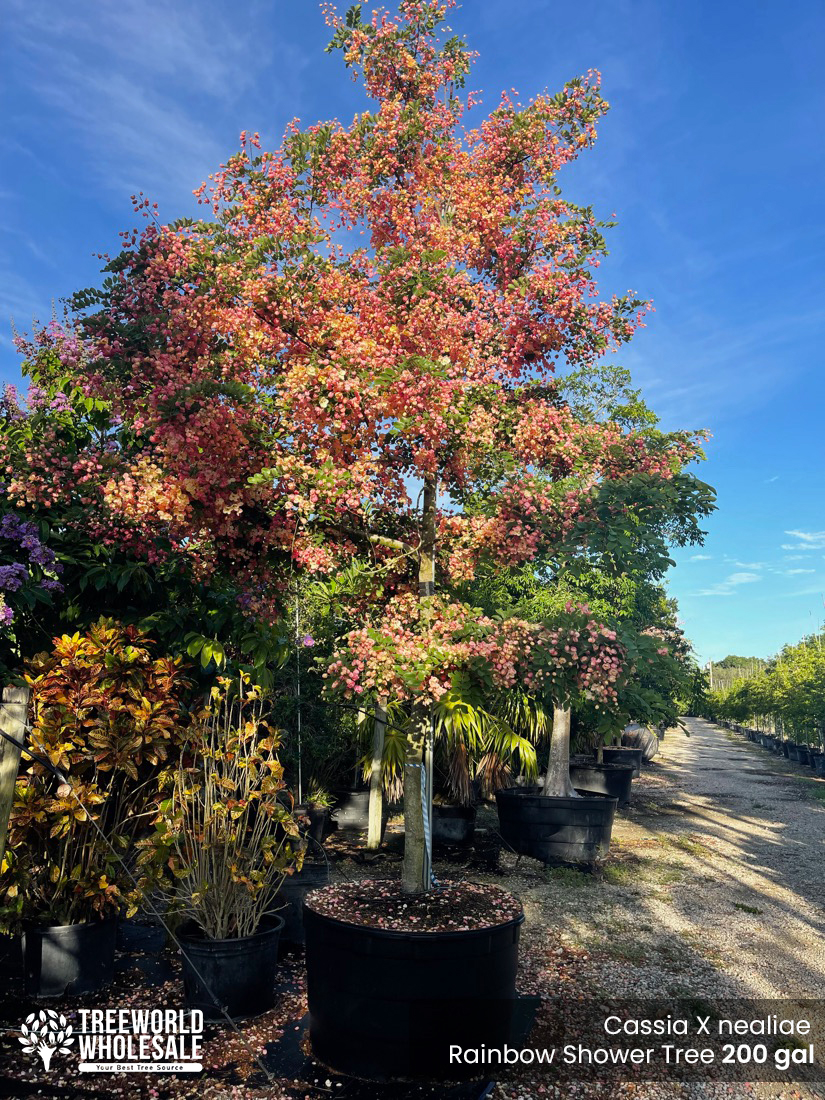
[{"xmin": 0, "ymin": 619, "xmax": 190, "ymax": 997}]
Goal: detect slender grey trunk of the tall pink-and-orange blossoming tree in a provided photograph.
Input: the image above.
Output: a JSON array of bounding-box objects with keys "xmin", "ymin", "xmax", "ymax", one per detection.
[{"xmin": 402, "ymin": 477, "xmax": 437, "ymax": 894}]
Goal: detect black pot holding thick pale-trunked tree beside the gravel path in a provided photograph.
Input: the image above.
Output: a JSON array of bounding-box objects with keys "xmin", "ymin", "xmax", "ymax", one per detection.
[{"xmin": 496, "ymin": 787, "xmax": 617, "ymax": 865}]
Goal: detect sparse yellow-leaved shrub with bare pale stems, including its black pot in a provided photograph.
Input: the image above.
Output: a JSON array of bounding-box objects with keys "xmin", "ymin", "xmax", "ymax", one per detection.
[{"xmin": 134, "ymin": 674, "xmax": 305, "ymax": 1019}]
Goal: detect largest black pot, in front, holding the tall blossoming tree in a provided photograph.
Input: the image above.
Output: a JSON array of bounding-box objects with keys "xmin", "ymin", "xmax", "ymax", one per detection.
[{"xmin": 304, "ymin": 905, "xmax": 524, "ymax": 1082}]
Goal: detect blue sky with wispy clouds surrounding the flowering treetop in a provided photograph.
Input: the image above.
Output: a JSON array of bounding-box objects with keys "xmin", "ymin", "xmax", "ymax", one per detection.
[{"xmin": 0, "ymin": 0, "xmax": 825, "ymax": 659}]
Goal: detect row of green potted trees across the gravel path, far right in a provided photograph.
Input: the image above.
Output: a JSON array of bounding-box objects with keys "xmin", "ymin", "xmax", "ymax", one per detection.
[{"xmin": 705, "ymin": 634, "xmax": 825, "ymax": 744}]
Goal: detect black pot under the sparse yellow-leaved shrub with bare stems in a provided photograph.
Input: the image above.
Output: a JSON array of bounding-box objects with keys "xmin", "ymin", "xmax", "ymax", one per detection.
[{"xmin": 178, "ymin": 916, "xmax": 284, "ymax": 1020}]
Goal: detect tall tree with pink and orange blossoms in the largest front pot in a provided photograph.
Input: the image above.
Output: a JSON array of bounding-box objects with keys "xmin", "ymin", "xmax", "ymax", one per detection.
[{"xmin": 6, "ymin": 0, "xmax": 712, "ymax": 889}]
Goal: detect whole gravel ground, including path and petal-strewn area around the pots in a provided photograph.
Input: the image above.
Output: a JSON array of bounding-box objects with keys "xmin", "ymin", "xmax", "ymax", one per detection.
[{"xmin": 0, "ymin": 719, "xmax": 825, "ymax": 1100}]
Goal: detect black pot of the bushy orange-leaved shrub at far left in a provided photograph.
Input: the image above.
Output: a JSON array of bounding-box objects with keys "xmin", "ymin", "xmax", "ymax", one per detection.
[{"xmin": 22, "ymin": 917, "xmax": 118, "ymax": 997}]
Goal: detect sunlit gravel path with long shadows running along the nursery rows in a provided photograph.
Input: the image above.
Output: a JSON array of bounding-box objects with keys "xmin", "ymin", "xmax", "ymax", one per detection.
[{"xmin": 618, "ymin": 718, "xmax": 825, "ymax": 998}]
